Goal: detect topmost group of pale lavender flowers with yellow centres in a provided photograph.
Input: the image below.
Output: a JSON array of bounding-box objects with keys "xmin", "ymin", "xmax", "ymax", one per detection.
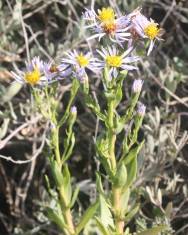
[{"xmin": 83, "ymin": 7, "xmax": 163, "ymax": 55}]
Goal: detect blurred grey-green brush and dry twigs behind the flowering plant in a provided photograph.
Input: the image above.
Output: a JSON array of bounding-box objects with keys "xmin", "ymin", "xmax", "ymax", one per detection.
[{"xmin": 0, "ymin": 0, "xmax": 188, "ymax": 235}]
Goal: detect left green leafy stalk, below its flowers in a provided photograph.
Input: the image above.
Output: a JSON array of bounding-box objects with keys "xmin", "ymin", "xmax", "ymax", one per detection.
[{"xmin": 34, "ymin": 83, "xmax": 79, "ymax": 235}]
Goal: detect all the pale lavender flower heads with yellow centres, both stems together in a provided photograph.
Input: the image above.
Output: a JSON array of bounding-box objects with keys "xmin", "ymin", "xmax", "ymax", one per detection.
[{"xmin": 12, "ymin": 7, "xmax": 162, "ymax": 91}]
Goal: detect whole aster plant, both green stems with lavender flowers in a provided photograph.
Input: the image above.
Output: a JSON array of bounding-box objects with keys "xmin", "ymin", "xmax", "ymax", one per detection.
[{"xmin": 9, "ymin": 4, "xmax": 169, "ymax": 235}]
